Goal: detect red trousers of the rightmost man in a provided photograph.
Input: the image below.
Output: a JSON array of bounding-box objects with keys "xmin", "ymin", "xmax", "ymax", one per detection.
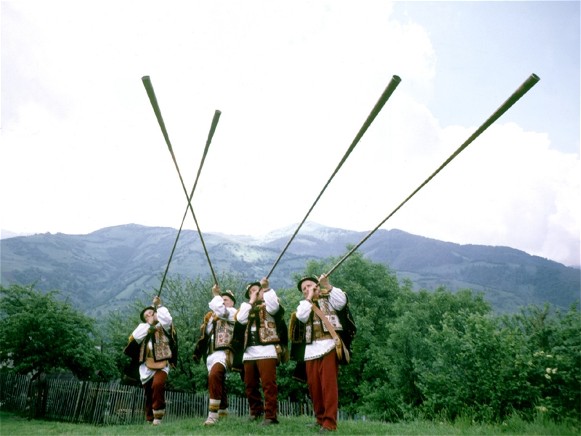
[{"xmin": 305, "ymin": 350, "xmax": 339, "ymax": 430}]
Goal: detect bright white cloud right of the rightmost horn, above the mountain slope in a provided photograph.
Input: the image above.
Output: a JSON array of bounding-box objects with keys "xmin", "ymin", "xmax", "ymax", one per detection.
[{"xmin": 380, "ymin": 123, "xmax": 580, "ymax": 265}]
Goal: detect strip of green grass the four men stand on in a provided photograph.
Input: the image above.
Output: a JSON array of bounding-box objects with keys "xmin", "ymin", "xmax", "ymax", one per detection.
[{"xmin": 0, "ymin": 412, "xmax": 581, "ymax": 436}]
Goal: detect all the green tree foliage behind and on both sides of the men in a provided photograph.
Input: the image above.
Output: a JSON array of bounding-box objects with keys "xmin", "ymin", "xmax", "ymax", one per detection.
[{"xmin": 0, "ymin": 253, "xmax": 581, "ymax": 422}]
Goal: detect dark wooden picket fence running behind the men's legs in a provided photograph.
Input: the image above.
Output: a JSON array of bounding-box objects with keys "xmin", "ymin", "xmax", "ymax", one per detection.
[{"xmin": 0, "ymin": 373, "xmax": 313, "ymax": 425}]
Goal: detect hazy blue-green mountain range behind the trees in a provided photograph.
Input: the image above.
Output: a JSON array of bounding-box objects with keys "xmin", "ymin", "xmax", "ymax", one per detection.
[{"xmin": 0, "ymin": 222, "xmax": 581, "ymax": 316}]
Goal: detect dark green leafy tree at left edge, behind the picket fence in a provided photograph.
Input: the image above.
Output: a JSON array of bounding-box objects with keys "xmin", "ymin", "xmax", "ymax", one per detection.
[{"xmin": 0, "ymin": 285, "xmax": 106, "ymax": 379}]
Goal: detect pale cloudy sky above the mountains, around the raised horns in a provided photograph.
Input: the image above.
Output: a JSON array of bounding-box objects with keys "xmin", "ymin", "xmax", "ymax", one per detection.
[{"xmin": 0, "ymin": 0, "xmax": 581, "ymax": 266}]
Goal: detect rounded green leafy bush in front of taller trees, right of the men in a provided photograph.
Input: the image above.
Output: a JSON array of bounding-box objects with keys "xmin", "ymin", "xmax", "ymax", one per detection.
[{"xmin": 416, "ymin": 310, "xmax": 531, "ymax": 422}]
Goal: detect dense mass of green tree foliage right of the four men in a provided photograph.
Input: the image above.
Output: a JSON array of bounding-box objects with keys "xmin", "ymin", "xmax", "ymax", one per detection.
[{"xmin": 290, "ymin": 253, "xmax": 581, "ymax": 422}]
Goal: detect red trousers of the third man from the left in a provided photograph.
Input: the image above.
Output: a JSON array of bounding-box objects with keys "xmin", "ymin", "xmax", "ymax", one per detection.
[{"xmin": 244, "ymin": 359, "xmax": 278, "ymax": 420}]
